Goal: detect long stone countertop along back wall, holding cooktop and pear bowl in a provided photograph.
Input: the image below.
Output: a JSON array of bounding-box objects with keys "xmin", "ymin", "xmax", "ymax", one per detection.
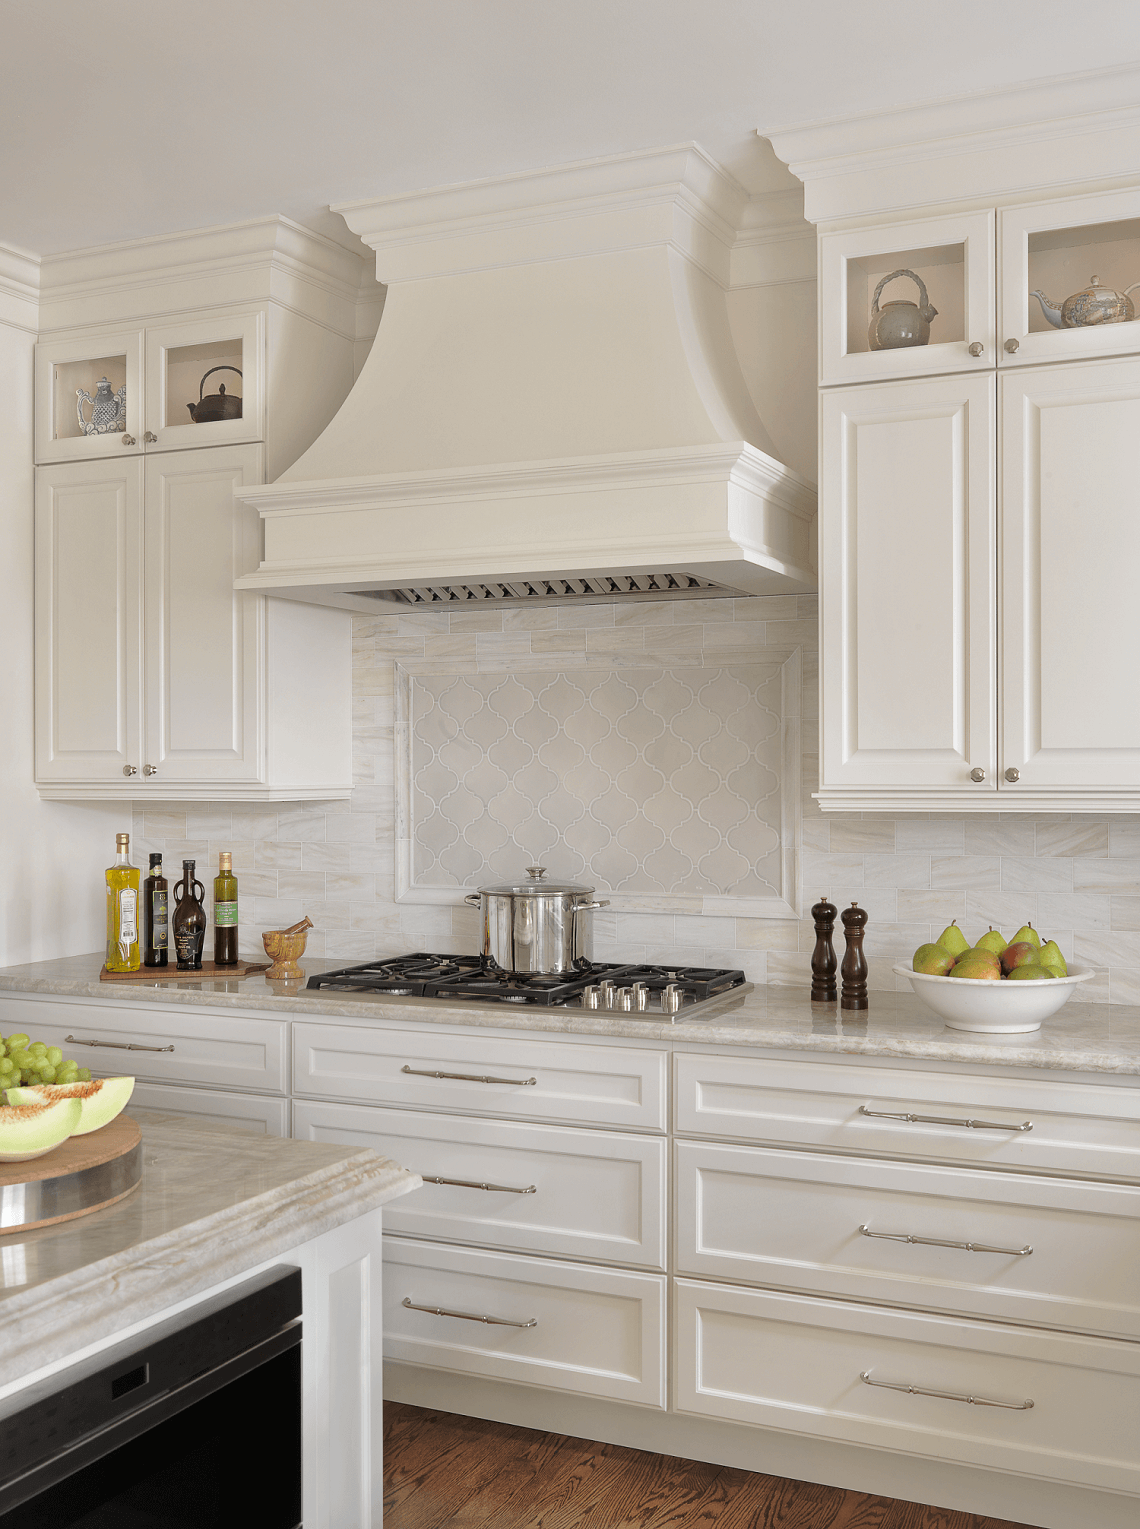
[{"xmin": 0, "ymin": 956, "xmax": 1140, "ymax": 1076}]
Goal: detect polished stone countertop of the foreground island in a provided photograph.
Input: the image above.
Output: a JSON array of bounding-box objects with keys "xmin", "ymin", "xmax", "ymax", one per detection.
[{"xmin": 0, "ymin": 1109, "xmax": 422, "ymax": 1387}]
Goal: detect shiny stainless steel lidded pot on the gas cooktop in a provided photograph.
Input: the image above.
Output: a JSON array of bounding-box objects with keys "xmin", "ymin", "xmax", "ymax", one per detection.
[{"xmin": 463, "ymin": 865, "xmax": 610, "ymax": 977}]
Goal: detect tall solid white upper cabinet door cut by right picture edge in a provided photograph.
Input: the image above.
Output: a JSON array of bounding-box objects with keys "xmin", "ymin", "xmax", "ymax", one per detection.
[{"xmin": 1001, "ymin": 351, "xmax": 1140, "ymax": 810}]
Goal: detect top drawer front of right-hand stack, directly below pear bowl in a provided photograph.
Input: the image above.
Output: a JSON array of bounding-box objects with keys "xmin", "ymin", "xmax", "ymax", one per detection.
[{"xmin": 675, "ymin": 1053, "xmax": 1140, "ymax": 1180}]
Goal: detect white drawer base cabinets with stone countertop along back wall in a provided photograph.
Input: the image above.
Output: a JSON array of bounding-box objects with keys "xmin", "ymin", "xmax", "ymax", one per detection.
[{"xmin": 0, "ymin": 956, "xmax": 1140, "ymax": 1529}]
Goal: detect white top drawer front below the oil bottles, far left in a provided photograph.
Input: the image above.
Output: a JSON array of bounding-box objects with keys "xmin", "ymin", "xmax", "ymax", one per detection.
[{"xmin": 5, "ymin": 1000, "xmax": 289, "ymax": 1093}]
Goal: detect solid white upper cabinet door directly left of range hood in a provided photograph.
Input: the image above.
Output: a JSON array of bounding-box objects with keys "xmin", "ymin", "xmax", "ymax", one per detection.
[{"xmin": 144, "ymin": 446, "xmax": 264, "ymax": 776}]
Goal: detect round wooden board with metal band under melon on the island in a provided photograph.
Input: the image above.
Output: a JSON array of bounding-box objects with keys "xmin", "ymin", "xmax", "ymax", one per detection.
[{"xmin": 0, "ymin": 1115, "xmax": 142, "ymax": 1237}]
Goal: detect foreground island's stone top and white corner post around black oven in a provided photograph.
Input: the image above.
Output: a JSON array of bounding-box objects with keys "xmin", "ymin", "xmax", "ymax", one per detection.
[{"xmin": 0, "ymin": 1105, "xmax": 420, "ymax": 1529}]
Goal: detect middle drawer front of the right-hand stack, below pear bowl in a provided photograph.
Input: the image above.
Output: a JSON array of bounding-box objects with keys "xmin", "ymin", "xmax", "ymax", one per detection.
[{"xmin": 675, "ymin": 1142, "xmax": 1140, "ymax": 1338}]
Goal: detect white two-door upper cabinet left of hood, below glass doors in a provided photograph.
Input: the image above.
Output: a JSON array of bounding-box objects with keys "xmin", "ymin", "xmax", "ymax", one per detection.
[{"xmin": 35, "ymin": 445, "xmax": 351, "ymax": 800}]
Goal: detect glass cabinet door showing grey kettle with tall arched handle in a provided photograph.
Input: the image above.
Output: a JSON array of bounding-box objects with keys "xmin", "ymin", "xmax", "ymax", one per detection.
[{"xmin": 819, "ymin": 211, "xmax": 996, "ymax": 384}]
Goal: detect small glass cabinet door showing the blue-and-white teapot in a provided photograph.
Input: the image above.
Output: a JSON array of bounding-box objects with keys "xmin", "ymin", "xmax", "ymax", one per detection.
[{"xmin": 35, "ymin": 329, "xmax": 144, "ymax": 462}]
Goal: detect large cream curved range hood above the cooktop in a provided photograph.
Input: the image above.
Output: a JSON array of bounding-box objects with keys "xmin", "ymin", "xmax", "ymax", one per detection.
[{"xmin": 237, "ymin": 145, "xmax": 816, "ymax": 613}]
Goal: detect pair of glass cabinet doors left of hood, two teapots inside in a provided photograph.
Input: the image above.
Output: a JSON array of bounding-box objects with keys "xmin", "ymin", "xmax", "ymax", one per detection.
[{"xmin": 35, "ymin": 309, "xmax": 266, "ymax": 463}]
